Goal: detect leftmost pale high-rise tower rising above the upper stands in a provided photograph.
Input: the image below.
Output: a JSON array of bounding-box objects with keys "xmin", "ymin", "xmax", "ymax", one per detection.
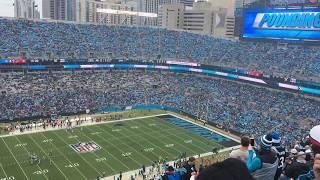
[{"xmin": 14, "ymin": 0, "xmax": 40, "ymax": 19}]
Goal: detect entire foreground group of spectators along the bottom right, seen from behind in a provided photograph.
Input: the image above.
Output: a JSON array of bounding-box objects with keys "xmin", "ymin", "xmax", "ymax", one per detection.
[{"xmin": 160, "ymin": 125, "xmax": 320, "ymax": 180}]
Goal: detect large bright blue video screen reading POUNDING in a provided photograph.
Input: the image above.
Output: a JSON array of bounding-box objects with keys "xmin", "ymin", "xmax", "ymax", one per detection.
[{"xmin": 242, "ymin": 9, "xmax": 320, "ymax": 43}]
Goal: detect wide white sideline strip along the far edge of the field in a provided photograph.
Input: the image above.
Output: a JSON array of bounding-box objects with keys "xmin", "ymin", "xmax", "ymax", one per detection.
[{"xmin": 0, "ymin": 113, "xmax": 168, "ymax": 137}]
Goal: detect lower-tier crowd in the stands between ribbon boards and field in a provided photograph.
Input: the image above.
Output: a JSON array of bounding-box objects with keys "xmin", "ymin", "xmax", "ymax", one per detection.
[{"xmin": 0, "ymin": 70, "xmax": 320, "ymax": 146}]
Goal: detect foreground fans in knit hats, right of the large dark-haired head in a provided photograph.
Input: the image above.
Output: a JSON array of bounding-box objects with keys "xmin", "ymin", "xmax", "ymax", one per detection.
[{"xmin": 222, "ymin": 125, "xmax": 320, "ymax": 180}]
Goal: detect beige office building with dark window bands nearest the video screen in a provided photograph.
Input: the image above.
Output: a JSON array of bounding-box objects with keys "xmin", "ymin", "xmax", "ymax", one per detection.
[{"xmin": 159, "ymin": 1, "xmax": 234, "ymax": 38}]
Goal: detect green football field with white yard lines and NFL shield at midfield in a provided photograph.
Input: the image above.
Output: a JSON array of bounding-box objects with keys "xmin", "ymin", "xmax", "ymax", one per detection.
[{"xmin": 0, "ymin": 114, "xmax": 238, "ymax": 180}]
